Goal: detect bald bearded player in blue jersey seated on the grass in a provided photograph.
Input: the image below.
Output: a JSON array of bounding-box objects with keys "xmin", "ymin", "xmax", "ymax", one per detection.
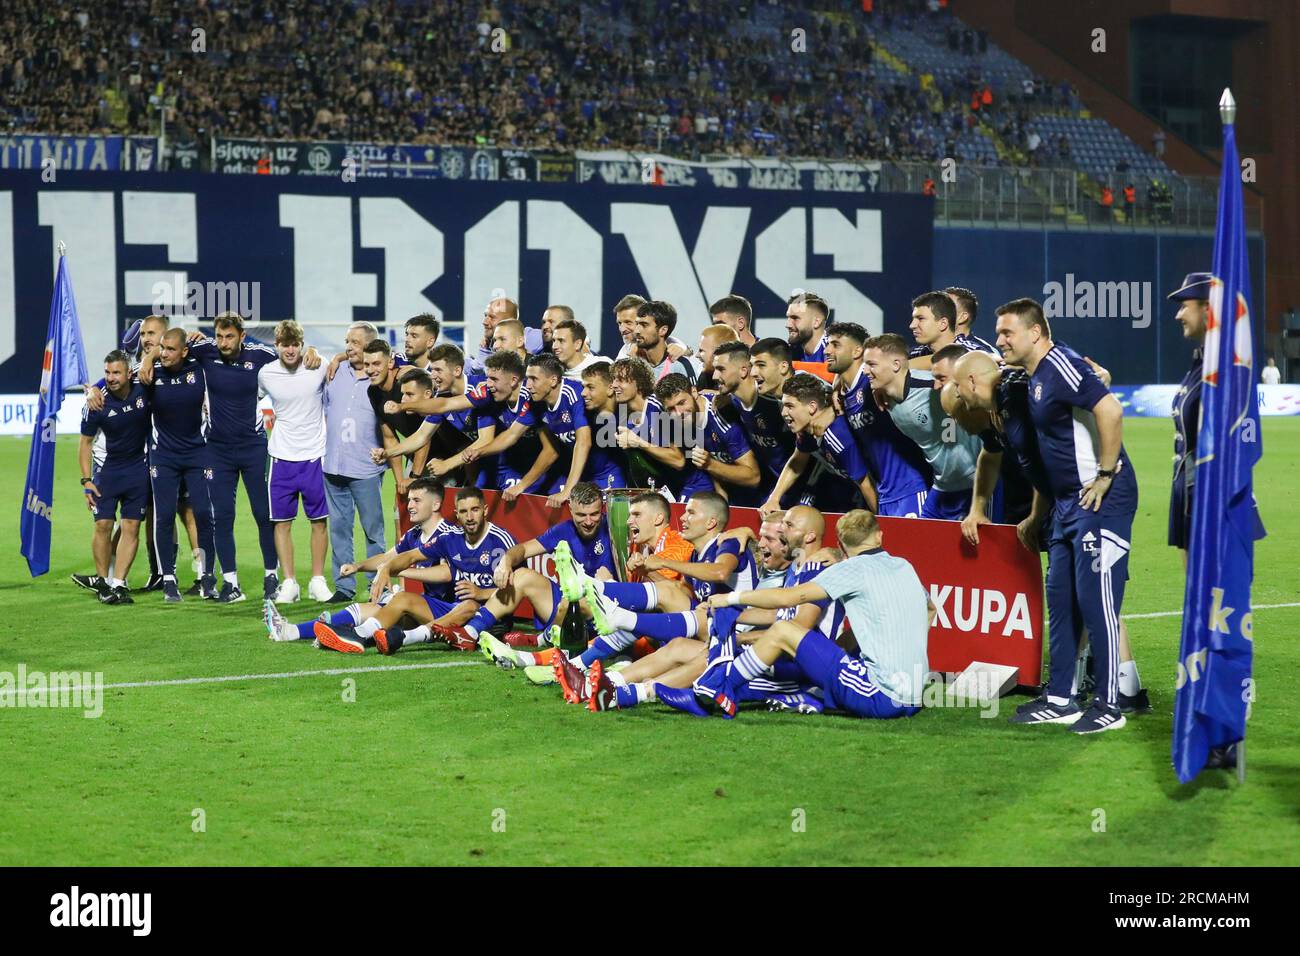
[{"xmin": 584, "ymin": 505, "xmax": 844, "ymax": 711}]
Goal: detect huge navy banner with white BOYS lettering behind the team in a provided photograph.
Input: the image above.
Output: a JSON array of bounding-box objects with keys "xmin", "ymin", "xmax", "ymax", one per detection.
[{"xmin": 0, "ymin": 170, "xmax": 933, "ymax": 392}]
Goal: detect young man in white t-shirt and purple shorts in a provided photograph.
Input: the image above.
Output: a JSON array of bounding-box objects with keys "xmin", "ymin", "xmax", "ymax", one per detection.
[{"xmin": 257, "ymin": 319, "xmax": 333, "ymax": 604}]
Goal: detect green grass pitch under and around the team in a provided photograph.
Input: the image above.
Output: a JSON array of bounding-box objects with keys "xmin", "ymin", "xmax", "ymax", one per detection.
[{"xmin": 0, "ymin": 419, "xmax": 1300, "ymax": 866}]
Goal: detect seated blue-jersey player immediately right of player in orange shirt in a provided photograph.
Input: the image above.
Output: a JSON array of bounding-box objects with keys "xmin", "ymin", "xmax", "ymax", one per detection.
[{"xmin": 543, "ymin": 492, "xmax": 758, "ymax": 704}]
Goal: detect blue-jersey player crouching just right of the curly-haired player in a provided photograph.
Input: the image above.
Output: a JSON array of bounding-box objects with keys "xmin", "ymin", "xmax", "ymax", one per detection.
[{"xmin": 655, "ymin": 374, "xmax": 762, "ymax": 507}]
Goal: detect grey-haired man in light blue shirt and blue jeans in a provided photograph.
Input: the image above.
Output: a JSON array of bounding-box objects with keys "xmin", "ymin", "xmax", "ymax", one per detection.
[{"xmin": 322, "ymin": 323, "xmax": 387, "ymax": 604}]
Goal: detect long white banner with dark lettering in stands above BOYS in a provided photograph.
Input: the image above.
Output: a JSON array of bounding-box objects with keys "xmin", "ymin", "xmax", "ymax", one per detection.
[{"xmin": 577, "ymin": 151, "xmax": 880, "ymax": 193}]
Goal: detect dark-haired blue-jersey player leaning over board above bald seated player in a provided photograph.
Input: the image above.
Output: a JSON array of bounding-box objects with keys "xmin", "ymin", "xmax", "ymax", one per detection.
[{"xmin": 759, "ymin": 375, "xmax": 878, "ymax": 514}]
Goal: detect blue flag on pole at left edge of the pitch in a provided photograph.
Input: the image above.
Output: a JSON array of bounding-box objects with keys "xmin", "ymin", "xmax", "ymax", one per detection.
[{"xmin": 18, "ymin": 255, "xmax": 87, "ymax": 578}]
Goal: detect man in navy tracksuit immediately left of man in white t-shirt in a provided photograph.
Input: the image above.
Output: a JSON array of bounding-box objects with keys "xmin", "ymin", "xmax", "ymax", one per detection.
[{"xmin": 190, "ymin": 312, "xmax": 282, "ymax": 604}]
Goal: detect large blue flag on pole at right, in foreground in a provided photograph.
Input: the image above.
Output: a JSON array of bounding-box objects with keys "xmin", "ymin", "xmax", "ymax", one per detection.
[{"xmin": 1173, "ymin": 91, "xmax": 1262, "ymax": 783}]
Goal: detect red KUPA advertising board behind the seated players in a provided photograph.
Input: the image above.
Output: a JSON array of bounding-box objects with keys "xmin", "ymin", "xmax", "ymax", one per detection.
[{"xmin": 442, "ymin": 489, "xmax": 1043, "ymax": 687}]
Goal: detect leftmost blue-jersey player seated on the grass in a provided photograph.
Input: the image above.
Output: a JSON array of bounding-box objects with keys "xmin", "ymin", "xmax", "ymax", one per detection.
[{"xmin": 263, "ymin": 479, "xmax": 467, "ymax": 654}]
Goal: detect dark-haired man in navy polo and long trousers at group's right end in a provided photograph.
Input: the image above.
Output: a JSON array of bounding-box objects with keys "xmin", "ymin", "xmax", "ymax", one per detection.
[{"xmin": 997, "ymin": 298, "xmax": 1138, "ymax": 734}]
